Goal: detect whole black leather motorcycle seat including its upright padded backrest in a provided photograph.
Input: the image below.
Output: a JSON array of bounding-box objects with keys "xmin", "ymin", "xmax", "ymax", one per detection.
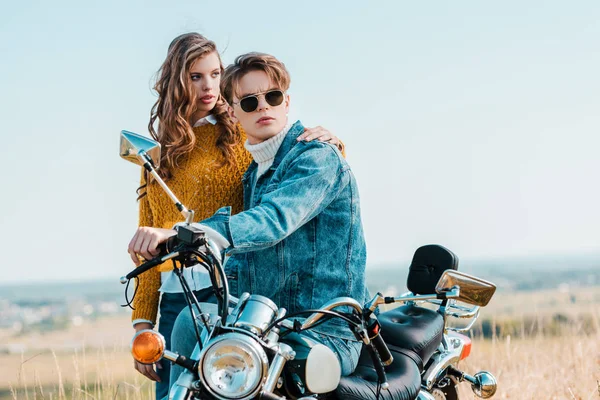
[{"xmin": 335, "ymin": 245, "xmax": 458, "ymax": 400}]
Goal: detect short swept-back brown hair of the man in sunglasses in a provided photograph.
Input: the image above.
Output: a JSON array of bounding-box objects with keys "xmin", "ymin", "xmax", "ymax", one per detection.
[{"xmin": 221, "ymin": 52, "xmax": 291, "ymax": 104}]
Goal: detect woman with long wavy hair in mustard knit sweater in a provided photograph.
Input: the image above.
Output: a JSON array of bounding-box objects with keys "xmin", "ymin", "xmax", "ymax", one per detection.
[{"xmin": 128, "ymin": 33, "xmax": 341, "ymax": 399}]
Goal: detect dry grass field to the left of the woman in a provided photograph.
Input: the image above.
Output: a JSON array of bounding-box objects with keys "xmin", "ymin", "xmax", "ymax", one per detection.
[{"xmin": 0, "ymin": 315, "xmax": 152, "ymax": 400}]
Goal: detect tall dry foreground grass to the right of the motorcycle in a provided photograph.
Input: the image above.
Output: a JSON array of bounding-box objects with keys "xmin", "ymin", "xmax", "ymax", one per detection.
[{"xmin": 461, "ymin": 334, "xmax": 600, "ymax": 400}]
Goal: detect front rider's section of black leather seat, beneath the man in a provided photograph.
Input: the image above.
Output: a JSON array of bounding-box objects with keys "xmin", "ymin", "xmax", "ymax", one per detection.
[{"xmin": 335, "ymin": 348, "xmax": 421, "ymax": 400}]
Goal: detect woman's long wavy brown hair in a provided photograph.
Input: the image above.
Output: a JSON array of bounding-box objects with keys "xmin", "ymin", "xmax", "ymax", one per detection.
[{"xmin": 138, "ymin": 32, "xmax": 240, "ymax": 198}]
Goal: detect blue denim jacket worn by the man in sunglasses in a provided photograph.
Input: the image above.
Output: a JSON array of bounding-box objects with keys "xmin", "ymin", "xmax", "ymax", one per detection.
[{"xmin": 200, "ymin": 121, "xmax": 366, "ymax": 339}]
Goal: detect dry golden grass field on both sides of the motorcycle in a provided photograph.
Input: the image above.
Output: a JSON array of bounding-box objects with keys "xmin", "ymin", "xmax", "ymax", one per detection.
[{"xmin": 0, "ymin": 288, "xmax": 600, "ymax": 400}]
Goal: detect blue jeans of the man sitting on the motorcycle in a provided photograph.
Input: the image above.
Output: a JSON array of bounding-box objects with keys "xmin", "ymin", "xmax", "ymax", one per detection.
[{"xmin": 170, "ymin": 310, "xmax": 362, "ymax": 392}]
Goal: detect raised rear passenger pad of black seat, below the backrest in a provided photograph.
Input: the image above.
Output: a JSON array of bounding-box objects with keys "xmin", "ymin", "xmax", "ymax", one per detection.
[{"xmin": 378, "ymin": 305, "xmax": 444, "ymax": 370}]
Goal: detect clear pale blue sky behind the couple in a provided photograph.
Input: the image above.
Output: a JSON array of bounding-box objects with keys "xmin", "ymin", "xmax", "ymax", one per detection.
[{"xmin": 0, "ymin": 0, "xmax": 600, "ymax": 282}]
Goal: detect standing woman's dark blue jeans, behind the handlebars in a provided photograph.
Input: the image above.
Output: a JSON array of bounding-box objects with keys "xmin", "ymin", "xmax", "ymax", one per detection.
[{"xmin": 156, "ymin": 288, "xmax": 212, "ymax": 400}]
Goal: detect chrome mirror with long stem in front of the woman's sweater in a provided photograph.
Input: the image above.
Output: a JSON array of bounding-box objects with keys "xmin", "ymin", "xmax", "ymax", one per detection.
[{"xmin": 119, "ymin": 131, "xmax": 194, "ymax": 224}]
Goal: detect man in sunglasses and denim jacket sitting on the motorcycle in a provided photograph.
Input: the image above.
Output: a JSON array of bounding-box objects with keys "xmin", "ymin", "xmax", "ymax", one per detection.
[{"xmin": 139, "ymin": 53, "xmax": 366, "ymax": 381}]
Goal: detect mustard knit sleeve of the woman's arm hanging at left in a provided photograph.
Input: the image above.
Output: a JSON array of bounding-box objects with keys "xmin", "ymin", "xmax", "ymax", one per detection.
[{"xmin": 131, "ymin": 169, "xmax": 160, "ymax": 324}]
